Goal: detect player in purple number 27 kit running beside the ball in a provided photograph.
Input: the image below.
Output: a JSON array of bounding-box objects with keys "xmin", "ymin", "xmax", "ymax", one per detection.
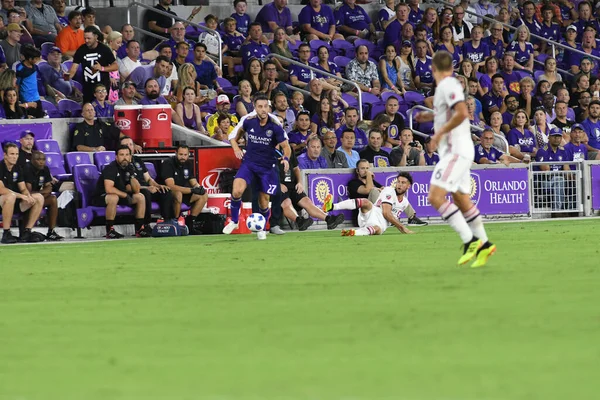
[{"xmin": 223, "ymin": 95, "xmax": 292, "ymax": 240}]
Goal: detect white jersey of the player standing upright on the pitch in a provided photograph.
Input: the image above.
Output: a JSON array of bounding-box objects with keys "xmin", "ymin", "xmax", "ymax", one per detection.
[{"xmin": 433, "ymin": 77, "xmax": 475, "ymax": 160}]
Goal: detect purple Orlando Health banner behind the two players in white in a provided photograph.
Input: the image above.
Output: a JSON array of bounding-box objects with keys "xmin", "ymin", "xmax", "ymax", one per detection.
[{"xmin": 307, "ymin": 166, "xmax": 528, "ymax": 217}]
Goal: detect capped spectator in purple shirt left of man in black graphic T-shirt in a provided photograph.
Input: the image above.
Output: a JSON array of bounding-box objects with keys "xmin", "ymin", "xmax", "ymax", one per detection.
[{"xmin": 38, "ymin": 46, "xmax": 83, "ymax": 102}]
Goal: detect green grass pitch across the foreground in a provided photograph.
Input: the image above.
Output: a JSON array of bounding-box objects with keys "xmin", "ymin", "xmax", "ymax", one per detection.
[{"xmin": 0, "ymin": 220, "xmax": 600, "ymax": 400}]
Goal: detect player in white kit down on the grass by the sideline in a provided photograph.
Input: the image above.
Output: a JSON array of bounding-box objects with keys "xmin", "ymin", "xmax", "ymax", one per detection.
[{"xmin": 323, "ymin": 172, "xmax": 414, "ymax": 236}]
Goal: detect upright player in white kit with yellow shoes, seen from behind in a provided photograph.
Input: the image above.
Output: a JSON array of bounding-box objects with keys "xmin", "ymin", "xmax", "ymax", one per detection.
[{"xmin": 416, "ymin": 51, "xmax": 496, "ymax": 267}]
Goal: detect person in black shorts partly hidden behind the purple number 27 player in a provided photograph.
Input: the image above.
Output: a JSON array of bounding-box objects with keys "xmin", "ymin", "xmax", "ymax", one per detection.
[{"xmin": 271, "ymin": 146, "xmax": 344, "ymax": 231}]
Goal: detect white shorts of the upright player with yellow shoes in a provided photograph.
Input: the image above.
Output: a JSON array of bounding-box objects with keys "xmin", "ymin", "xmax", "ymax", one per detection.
[{"xmin": 430, "ymin": 154, "xmax": 473, "ymax": 194}]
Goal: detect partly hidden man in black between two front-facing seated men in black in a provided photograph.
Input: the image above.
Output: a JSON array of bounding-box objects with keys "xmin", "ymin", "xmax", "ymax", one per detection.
[{"xmin": 121, "ymin": 136, "xmax": 175, "ymax": 226}]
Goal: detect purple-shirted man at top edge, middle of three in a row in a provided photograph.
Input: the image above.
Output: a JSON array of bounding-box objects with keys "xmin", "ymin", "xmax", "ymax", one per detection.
[{"xmin": 298, "ymin": 0, "xmax": 344, "ymax": 42}]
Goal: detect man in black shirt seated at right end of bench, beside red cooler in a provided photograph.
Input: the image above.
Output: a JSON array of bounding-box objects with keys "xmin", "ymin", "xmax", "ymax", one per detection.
[{"xmin": 161, "ymin": 144, "xmax": 208, "ymax": 234}]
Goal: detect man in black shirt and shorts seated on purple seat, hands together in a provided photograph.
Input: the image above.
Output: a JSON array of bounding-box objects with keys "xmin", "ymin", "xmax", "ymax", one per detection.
[{"xmin": 92, "ymin": 146, "xmax": 152, "ymax": 239}]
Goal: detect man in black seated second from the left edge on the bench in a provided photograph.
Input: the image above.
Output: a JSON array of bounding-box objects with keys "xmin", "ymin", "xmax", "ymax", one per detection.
[{"xmin": 23, "ymin": 150, "xmax": 63, "ymax": 241}]
